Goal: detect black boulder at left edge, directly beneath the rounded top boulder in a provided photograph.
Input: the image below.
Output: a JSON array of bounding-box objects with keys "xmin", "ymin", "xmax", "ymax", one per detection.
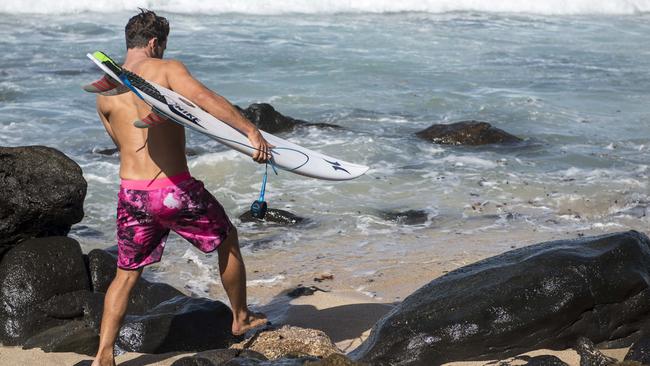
[{"xmin": 0, "ymin": 237, "xmax": 90, "ymax": 345}]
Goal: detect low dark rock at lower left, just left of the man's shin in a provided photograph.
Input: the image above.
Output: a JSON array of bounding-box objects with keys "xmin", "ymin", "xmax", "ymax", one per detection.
[{"xmin": 23, "ymin": 320, "xmax": 99, "ymax": 356}]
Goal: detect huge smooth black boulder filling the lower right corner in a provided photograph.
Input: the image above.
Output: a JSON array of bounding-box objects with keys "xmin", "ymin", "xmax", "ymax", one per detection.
[{"xmin": 352, "ymin": 231, "xmax": 650, "ymax": 365}]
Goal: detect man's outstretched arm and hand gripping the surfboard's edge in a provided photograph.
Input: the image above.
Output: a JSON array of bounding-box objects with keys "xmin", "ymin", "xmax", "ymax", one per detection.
[{"xmin": 165, "ymin": 60, "xmax": 271, "ymax": 163}]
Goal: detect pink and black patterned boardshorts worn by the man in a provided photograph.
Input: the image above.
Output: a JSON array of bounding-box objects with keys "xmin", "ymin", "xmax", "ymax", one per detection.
[{"xmin": 117, "ymin": 172, "xmax": 232, "ymax": 269}]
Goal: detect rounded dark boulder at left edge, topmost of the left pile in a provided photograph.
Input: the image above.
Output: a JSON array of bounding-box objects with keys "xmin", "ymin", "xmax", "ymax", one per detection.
[{"xmin": 0, "ymin": 146, "xmax": 86, "ymax": 256}]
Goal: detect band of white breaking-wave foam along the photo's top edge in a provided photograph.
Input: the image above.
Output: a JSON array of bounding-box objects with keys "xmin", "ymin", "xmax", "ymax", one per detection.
[{"xmin": 0, "ymin": 0, "xmax": 650, "ymax": 15}]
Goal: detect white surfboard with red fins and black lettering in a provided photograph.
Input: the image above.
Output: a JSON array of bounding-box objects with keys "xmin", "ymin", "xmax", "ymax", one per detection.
[{"xmin": 83, "ymin": 51, "xmax": 369, "ymax": 181}]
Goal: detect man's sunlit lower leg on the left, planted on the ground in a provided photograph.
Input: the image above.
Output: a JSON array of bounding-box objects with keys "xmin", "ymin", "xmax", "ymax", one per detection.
[{"xmin": 92, "ymin": 268, "xmax": 142, "ymax": 366}]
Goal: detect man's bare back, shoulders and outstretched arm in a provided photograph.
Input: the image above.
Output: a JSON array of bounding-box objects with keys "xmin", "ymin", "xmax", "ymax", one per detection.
[{"xmin": 97, "ymin": 53, "xmax": 269, "ymax": 180}]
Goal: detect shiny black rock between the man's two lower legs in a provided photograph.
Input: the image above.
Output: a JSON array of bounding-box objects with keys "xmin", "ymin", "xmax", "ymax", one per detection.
[{"xmin": 116, "ymin": 296, "xmax": 235, "ymax": 353}]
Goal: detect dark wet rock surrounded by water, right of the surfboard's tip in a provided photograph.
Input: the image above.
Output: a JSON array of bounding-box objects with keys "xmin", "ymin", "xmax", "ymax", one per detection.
[{"xmin": 416, "ymin": 120, "xmax": 522, "ymax": 145}]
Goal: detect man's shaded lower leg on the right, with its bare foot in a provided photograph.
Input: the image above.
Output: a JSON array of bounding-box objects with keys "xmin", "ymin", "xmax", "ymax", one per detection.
[{"xmin": 217, "ymin": 226, "xmax": 267, "ymax": 335}]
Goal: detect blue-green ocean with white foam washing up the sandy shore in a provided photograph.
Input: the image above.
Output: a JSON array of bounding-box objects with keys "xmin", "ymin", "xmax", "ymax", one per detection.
[{"xmin": 0, "ymin": 0, "xmax": 650, "ymax": 304}]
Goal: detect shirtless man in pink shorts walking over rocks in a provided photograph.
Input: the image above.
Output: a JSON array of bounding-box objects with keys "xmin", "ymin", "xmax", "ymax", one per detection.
[{"xmin": 93, "ymin": 10, "xmax": 271, "ymax": 366}]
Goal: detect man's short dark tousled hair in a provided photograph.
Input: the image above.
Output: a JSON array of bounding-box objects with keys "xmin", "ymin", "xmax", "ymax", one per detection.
[{"xmin": 124, "ymin": 8, "xmax": 169, "ymax": 49}]
